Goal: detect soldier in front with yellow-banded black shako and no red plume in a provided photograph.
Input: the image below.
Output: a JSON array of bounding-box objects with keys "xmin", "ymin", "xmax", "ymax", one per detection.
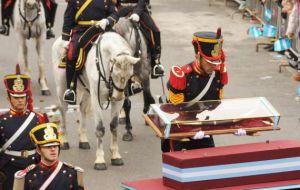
[{"xmin": 13, "ymin": 123, "xmax": 84, "ymax": 190}]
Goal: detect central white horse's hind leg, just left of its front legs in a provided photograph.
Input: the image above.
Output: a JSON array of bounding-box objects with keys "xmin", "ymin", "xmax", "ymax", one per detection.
[{"xmin": 78, "ymin": 92, "xmax": 91, "ymax": 149}]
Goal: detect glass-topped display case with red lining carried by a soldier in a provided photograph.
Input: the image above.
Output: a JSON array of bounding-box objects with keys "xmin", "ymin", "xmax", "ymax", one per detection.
[{"xmin": 144, "ymin": 97, "xmax": 280, "ymax": 139}]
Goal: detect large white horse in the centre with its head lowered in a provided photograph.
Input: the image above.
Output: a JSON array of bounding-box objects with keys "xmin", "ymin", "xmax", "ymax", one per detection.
[{"xmin": 52, "ymin": 32, "xmax": 139, "ymax": 170}]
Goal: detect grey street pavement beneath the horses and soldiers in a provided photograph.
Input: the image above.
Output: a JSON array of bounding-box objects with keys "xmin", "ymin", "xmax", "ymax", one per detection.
[{"xmin": 0, "ymin": 0, "xmax": 300, "ymax": 190}]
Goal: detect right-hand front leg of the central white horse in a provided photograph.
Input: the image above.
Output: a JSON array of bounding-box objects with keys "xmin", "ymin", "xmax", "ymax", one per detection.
[{"xmin": 110, "ymin": 101, "xmax": 124, "ymax": 166}]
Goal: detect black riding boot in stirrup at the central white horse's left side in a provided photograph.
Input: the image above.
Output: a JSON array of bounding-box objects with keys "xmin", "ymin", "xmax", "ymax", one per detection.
[{"xmin": 63, "ymin": 61, "xmax": 77, "ymax": 105}]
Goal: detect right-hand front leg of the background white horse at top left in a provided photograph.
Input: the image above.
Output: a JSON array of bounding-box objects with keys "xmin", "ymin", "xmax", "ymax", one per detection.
[{"xmin": 36, "ymin": 35, "xmax": 51, "ymax": 96}]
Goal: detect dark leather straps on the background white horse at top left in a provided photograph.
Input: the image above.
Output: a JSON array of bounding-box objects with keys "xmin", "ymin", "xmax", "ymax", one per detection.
[{"xmin": 18, "ymin": 0, "xmax": 41, "ymax": 39}]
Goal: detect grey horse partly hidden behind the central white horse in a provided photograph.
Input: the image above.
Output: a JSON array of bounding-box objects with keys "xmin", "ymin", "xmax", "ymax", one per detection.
[{"xmin": 114, "ymin": 17, "xmax": 155, "ymax": 141}]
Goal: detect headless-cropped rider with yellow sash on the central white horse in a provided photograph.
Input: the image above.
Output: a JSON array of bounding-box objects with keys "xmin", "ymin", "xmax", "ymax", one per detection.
[{"xmin": 62, "ymin": 0, "xmax": 119, "ymax": 104}]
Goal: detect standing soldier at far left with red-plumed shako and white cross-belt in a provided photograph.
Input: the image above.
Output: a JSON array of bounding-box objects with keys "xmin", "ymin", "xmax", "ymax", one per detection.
[{"xmin": 0, "ymin": 65, "xmax": 46, "ymax": 190}]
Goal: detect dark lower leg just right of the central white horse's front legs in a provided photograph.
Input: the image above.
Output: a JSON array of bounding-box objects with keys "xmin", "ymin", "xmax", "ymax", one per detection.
[{"xmin": 122, "ymin": 97, "xmax": 133, "ymax": 141}]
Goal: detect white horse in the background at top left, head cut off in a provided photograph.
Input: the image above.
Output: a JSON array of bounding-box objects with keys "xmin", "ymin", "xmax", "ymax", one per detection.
[{"xmin": 12, "ymin": 0, "xmax": 51, "ymax": 95}]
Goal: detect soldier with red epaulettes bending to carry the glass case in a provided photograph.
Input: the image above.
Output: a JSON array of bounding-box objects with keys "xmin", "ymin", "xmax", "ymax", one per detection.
[{"xmin": 162, "ymin": 28, "xmax": 228, "ymax": 152}]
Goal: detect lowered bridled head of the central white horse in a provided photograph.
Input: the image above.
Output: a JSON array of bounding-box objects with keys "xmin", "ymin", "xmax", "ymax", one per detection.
[{"xmin": 110, "ymin": 54, "xmax": 140, "ymax": 101}]
